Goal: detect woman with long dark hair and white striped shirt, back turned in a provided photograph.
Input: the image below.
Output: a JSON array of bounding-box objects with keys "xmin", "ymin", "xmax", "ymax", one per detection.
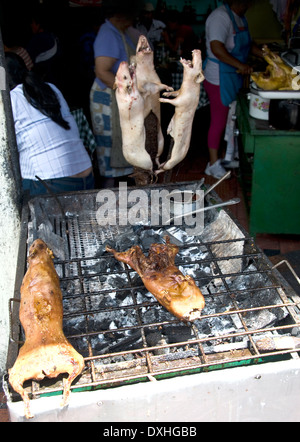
[{"xmin": 5, "ymin": 52, "xmax": 94, "ymax": 196}]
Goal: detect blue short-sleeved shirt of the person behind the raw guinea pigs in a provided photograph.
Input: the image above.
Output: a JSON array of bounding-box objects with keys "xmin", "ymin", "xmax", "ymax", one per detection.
[{"xmin": 94, "ymin": 20, "xmax": 135, "ymax": 89}]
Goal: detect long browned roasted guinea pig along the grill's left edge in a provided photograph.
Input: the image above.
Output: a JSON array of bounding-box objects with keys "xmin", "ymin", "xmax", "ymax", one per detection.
[{"xmin": 9, "ymin": 239, "xmax": 84, "ymax": 419}]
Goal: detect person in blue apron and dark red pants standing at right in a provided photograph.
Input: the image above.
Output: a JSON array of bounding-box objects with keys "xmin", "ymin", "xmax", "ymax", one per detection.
[{"xmin": 203, "ymin": 0, "xmax": 262, "ymax": 179}]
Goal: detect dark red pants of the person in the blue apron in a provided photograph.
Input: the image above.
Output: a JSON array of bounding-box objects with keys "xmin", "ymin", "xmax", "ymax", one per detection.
[{"xmin": 203, "ymin": 80, "xmax": 229, "ymax": 149}]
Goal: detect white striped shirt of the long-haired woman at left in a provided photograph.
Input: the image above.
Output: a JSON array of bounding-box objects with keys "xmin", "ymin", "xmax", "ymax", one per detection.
[{"xmin": 10, "ymin": 84, "xmax": 92, "ymax": 180}]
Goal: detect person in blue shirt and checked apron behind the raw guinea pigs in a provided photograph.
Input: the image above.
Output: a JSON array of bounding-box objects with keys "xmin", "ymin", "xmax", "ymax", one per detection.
[{"xmin": 90, "ymin": 0, "xmax": 140, "ymax": 187}]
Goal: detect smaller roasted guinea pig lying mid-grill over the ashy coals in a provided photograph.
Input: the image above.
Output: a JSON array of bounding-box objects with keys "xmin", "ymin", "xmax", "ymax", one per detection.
[{"xmin": 106, "ymin": 237, "xmax": 205, "ymax": 321}]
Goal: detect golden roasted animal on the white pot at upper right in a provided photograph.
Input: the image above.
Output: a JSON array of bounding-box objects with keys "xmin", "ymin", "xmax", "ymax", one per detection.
[{"xmin": 251, "ymin": 45, "xmax": 294, "ymax": 91}]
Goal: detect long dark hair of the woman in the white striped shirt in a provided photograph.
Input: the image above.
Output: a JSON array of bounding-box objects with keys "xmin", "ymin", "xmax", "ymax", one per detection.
[{"xmin": 5, "ymin": 52, "xmax": 70, "ymax": 129}]
